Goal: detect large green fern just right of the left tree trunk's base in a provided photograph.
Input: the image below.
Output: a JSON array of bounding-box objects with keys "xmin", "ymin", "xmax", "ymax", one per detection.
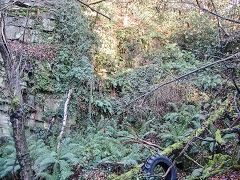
[{"xmin": 29, "ymin": 139, "xmax": 79, "ymax": 180}]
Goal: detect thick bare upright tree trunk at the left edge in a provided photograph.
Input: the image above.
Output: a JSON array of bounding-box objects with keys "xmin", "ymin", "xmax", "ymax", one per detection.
[{"xmin": 0, "ymin": 14, "xmax": 33, "ymax": 180}]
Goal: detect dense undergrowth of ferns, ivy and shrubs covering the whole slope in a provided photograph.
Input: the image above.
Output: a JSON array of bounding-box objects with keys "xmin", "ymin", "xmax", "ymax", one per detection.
[{"xmin": 0, "ymin": 1, "xmax": 239, "ymax": 180}]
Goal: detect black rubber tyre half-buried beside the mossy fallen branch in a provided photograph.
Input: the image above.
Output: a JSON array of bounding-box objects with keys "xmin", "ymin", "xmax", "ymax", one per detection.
[{"xmin": 142, "ymin": 154, "xmax": 177, "ymax": 180}]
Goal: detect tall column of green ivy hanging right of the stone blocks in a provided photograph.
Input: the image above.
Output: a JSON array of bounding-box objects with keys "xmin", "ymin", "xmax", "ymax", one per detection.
[{"xmin": 48, "ymin": 1, "xmax": 100, "ymax": 123}]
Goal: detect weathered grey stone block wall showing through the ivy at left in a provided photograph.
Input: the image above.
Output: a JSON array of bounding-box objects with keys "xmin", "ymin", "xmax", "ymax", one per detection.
[{"xmin": 0, "ymin": 0, "xmax": 59, "ymax": 137}]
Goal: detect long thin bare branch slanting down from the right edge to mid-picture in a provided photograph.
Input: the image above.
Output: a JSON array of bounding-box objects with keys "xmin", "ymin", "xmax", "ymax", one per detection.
[{"xmin": 125, "ymin": 52, "xmax": 240, "ymax": 108}]
